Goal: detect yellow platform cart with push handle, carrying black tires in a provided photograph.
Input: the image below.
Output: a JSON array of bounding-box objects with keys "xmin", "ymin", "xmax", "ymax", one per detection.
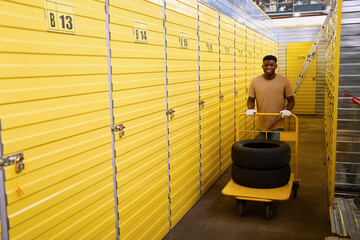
[{"xmin": 222, "ymin": 113, "xmax": 300, "ymax": 219}]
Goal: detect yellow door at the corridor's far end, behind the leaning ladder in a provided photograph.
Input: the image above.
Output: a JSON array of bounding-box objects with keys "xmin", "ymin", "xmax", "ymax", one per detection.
[{"xmin": 286, "ymin": 42, "xmax": 316, "ymax": 114}]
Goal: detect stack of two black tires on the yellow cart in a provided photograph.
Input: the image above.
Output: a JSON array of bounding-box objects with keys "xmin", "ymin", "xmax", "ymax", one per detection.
[{"xmin": 231, "ymin": 139, "xmax": 291, "ymax": 188}]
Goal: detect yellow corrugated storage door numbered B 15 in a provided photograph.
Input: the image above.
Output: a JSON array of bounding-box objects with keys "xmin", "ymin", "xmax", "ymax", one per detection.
[{"xmin": 166, "ymin": 0, "xmax": 200, "ymax": 226}]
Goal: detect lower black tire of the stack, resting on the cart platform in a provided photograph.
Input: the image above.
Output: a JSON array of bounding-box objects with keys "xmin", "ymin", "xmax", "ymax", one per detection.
[{"xmin": 231, "ymin": 164, "xmax": 291, "ymax": 188}]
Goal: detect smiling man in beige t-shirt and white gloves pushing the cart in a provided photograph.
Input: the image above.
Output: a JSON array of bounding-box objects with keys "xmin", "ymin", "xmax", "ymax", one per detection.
[{"xmin": 246, "ymin": 55, "xmax": 295, "ymax": 141}]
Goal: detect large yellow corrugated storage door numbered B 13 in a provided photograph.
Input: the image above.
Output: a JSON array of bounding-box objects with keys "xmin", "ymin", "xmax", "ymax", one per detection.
[{"xmin": 0, "ymin": 0, "xmax": 116, "ymax": 240}]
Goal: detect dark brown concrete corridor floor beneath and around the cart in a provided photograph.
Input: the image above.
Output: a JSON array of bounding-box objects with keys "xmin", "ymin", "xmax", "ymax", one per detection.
[{"xmin": 164, "ymin": 116, "xmax": 331, "ymax": 240}]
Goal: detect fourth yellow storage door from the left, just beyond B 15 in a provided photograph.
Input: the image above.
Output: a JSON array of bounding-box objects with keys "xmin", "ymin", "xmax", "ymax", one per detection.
[{"xmin": 199, "ymin": 4, "xmax": 220, "ymax": 194}]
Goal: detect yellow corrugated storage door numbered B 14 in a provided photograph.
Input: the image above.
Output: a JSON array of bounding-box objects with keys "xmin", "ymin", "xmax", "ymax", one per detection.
[{"xmin": 109, "ymin": 0, "xmax": 169, "ymax": 239}]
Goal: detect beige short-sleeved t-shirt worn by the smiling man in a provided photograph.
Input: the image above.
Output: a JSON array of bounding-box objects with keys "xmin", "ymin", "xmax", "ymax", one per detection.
[{"xmin": 248, "ymin": 74, "xmax": 294, "ymax": 131}]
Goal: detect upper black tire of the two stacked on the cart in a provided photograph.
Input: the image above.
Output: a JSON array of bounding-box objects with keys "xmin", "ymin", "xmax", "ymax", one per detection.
[{"xmin": 231, "ymin": 139, "xmax": 291, "ymax": 169}]
